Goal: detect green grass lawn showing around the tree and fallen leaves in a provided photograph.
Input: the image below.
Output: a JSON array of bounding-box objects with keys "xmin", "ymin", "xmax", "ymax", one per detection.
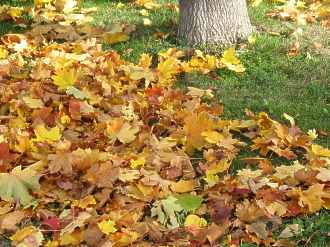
[{"xmin": 0, "ymin": 0, "xmax": 330, "ymax": 247}]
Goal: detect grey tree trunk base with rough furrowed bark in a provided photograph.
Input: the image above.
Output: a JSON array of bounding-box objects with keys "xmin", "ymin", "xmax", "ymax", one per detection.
[{"xmin": 179, "ymin": 0, "xmax": 252, "ymax": 45}]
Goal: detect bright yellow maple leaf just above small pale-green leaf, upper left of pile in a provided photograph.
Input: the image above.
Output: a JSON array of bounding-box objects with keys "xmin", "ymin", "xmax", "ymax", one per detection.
[{"xmin": 52, "ymin": 68, "xmax": 79, "ymax": 90}]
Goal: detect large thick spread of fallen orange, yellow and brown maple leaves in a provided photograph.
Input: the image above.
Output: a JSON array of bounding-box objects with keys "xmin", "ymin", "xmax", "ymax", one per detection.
[{"xmin": 0, "ymin": 1, "xmax": 330, "ymax": 247}]
